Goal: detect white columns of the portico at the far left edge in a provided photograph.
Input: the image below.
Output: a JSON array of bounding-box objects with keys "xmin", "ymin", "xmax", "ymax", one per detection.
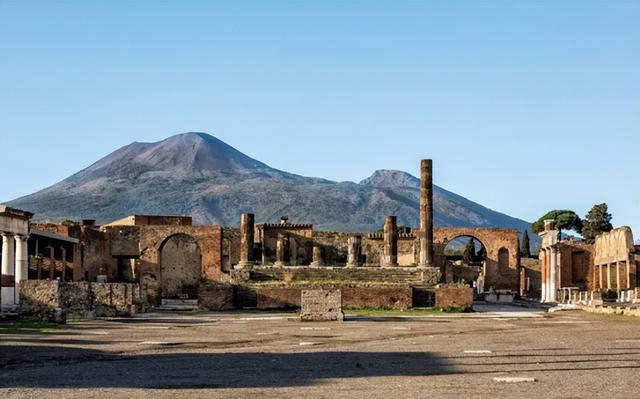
[{"xmin": 0, "ymin": 232, "xmax": 29, "ymax": 308}]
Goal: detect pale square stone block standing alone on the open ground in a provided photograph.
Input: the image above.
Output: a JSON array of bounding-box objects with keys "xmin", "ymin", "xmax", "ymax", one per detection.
[{"xmin": 300, "ymin": 290, "xmax": 344, "ymax": 321}]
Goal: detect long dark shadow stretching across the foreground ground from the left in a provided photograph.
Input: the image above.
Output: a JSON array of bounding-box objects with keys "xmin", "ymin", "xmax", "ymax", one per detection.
[{"xmin": 0, "ymin": 346, "xmax": 454, "ymax": 389}]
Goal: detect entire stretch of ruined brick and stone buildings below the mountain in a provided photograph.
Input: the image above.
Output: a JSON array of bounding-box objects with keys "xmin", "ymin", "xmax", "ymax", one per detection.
[{"xmin": 0, "ymin": 160, "xmax": 638, "ymax": 318}]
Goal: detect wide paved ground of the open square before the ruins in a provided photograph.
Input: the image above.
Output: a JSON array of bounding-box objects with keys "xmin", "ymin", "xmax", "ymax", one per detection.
[{"xmin": 0, "ymin": 307, "xmax": 640, "ymax": 399}]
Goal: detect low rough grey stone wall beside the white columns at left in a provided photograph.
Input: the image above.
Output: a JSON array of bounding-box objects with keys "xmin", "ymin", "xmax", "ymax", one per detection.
[{"xmin": 19, "ymin": 280, "xmax": 140, "ymax": 322}]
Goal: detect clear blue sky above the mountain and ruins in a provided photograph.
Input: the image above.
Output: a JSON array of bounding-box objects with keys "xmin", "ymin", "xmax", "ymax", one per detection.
[{"xmin": 0, "ymin": 0, "xmax": 640, "ymax": 234}]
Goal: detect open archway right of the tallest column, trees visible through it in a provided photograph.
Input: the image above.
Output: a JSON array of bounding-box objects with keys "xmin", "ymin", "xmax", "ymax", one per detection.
[{"xmin": 443, "ymin": 235, "xmax": 487, "ymax": 285}]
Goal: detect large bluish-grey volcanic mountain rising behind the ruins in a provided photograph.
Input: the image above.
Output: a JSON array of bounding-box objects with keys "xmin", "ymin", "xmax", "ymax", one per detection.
[{"xmin": 9, "ymin": 133, "xmax": 529, "ymax": 231}]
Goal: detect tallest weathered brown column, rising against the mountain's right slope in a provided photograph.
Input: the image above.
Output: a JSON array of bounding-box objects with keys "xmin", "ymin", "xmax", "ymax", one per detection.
[{"xmin": 418, "ymin": 159, "xmax": 433, "ymax": 267}]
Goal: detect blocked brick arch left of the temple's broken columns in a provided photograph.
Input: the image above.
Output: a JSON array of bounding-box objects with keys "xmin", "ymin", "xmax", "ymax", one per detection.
[{"xmin": 160, "ymin": 234, "xmax": 202, "ymax": 299}]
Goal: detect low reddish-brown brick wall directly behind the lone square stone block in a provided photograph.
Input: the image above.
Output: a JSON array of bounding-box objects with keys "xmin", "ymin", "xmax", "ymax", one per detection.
[{"xmin": 256, "ymin": 286, "xmax": 413, "ymax": 309}]
